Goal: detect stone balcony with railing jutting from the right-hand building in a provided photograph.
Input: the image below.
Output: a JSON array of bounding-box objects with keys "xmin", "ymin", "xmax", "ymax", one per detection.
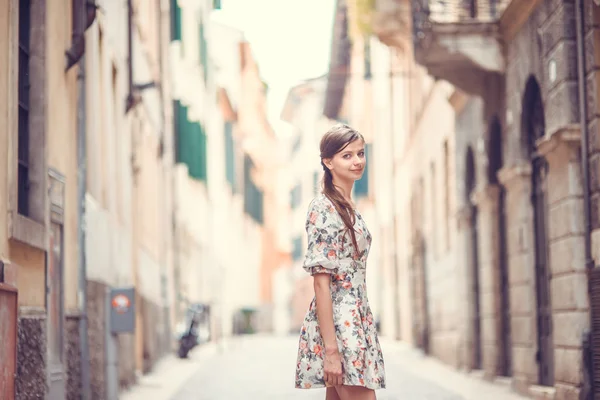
[{"xmin": 411, "ymin": 0, "xmax": 508, "ymax": 94}]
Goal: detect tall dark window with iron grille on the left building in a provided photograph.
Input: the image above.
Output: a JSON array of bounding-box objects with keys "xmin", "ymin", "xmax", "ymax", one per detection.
[{"xmin": 17, "ymin": 0, "xmax": 31, "ymax": 216}]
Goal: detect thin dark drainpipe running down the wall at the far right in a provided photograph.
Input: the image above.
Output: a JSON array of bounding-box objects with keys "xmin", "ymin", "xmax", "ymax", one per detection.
[{"xmin": 575, "ymin": 0, "xmax": 595, "ymax": 398}]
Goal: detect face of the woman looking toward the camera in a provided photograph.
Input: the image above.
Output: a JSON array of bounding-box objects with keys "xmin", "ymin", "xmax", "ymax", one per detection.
[{"xmin": 323, "ymin": 139, "xmax": 366, "ymax": 183}]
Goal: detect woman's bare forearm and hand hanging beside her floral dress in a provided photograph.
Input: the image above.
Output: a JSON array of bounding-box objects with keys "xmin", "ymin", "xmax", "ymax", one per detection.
[{"xmin": 314, "ymin": 273, "xmax": 342, "ymax": 386}]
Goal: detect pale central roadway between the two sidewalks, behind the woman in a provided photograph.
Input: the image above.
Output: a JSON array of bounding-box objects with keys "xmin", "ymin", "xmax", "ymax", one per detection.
[{"xmin": 172, "ymin": 337, "xmax": 463, "ymax": 400}]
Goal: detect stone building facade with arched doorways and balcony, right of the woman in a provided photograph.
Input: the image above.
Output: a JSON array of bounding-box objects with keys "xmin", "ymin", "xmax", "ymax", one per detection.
[{"xmin": 350, "ymin": 0, "xmax": 600, "ymax": 399}]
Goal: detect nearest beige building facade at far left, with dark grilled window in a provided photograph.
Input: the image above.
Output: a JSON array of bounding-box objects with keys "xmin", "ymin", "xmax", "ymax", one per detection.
[{"xmin": 0, "ymin": 0, "xmax": 95, "ymax": 398}]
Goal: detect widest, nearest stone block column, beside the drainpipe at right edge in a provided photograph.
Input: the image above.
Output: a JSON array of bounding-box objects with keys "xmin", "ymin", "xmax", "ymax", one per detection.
[{"xmin": 538, "ymin": 128, "xmax": 589, "ymax": 399}]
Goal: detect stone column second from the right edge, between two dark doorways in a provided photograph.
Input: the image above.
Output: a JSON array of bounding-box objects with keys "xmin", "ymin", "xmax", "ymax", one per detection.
[{"xmin": 498, "ymin": 161, "xmax": 538, "ymax": 394}]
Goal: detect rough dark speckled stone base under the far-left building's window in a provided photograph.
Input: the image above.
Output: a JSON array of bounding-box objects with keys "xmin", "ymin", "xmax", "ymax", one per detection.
[{"xmin": 15, "ymin": 310, "xmax": 48, "ymax": 400}]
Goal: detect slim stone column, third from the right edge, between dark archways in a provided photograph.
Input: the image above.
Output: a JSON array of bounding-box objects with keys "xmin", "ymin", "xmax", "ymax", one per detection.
[{"xmin": 472, "ymin": 184, "xmax": 502, "ymax": 378}]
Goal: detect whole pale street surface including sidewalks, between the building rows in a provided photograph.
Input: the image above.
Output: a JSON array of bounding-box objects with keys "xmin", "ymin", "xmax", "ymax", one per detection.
[{"xmin": 121, "ymin": 336, "xmax": 522, "ymax": 400}]
